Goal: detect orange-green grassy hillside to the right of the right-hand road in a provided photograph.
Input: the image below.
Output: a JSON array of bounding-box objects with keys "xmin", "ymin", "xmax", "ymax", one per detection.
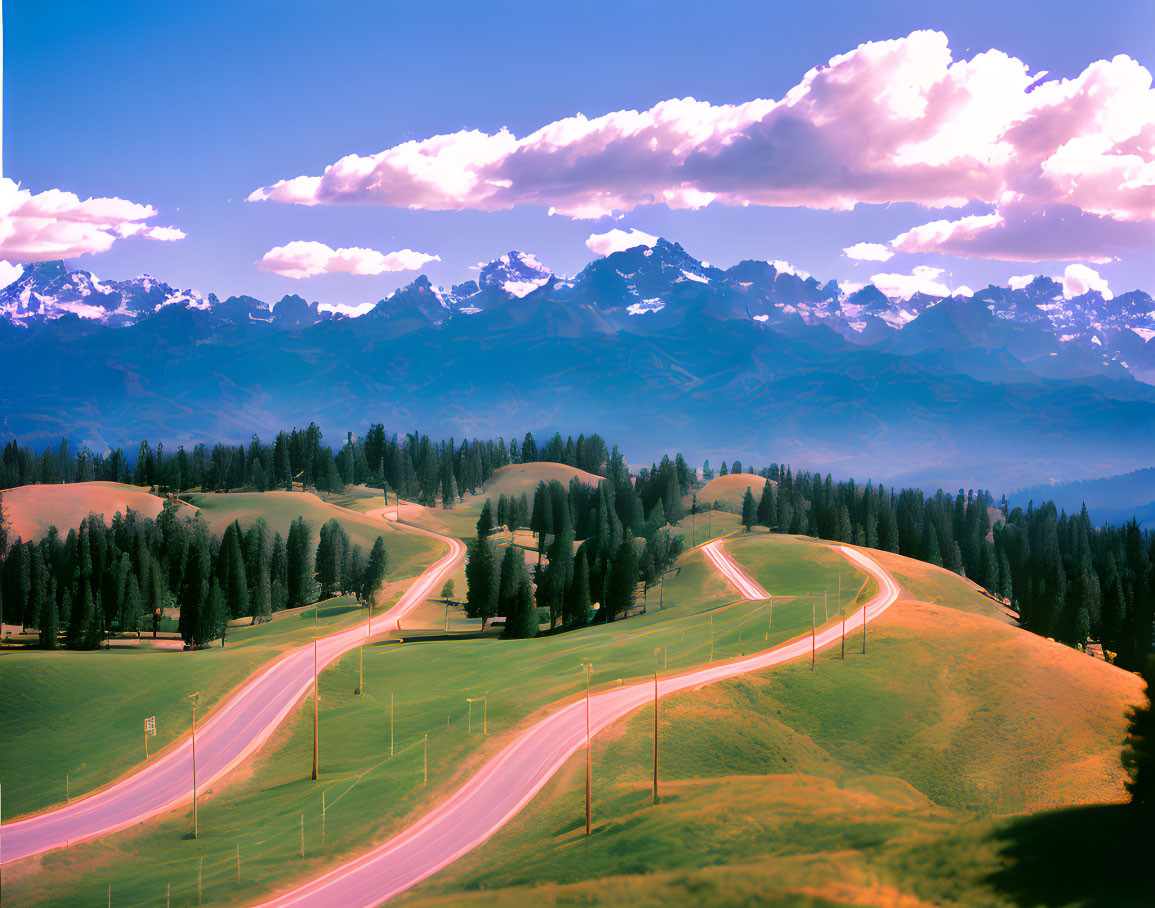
[{"xmin": 402, "ymin": 545, "xmax": 1149, "ymax": 906}]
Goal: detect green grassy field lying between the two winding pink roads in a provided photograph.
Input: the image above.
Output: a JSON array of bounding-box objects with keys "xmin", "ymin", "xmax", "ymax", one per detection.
[{"xmin": 6, "ymin": 539, "xmax": 868, "ymax": 905}]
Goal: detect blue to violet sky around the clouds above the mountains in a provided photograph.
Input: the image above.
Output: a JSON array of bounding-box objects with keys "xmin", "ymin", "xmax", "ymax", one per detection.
[{"xmin": 3, "ymin": 0, "xmax": 1155, "ymax": 304}]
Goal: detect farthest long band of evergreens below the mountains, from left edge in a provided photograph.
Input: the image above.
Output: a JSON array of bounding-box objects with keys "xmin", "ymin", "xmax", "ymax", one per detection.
[{"xmin": 0, "ymin": 423, "xmax": 609, "ymax": 507}]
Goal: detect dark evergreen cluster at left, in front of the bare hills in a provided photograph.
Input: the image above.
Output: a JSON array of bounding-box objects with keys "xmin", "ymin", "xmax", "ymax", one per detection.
[{"xmin": 0, "ymin": 501, "xmax": 388, "ymax": 649}]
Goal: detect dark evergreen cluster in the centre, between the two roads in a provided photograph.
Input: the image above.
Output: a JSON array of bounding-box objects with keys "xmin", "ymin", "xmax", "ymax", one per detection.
[{"xmin": 467, "ymin": 448, "xmax": 694, "ymax": 637}]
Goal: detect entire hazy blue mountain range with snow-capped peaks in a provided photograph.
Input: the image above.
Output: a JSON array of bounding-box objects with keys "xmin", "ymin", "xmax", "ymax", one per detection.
[{"xmin": 0, "ymin": 240, "xmax": 1155, "ymax": 489}]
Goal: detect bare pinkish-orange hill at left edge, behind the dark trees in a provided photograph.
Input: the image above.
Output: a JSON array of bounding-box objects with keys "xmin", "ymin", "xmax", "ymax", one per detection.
[{"xmin": 3, "ymin": 483, "xmax": 192, "ymax": 542}]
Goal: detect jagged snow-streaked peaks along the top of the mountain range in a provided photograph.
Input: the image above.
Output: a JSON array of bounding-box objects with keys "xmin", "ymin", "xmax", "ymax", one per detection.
[{"xmin": 0, "ymin": 239, "xmax": 1155, "ymax": 384}]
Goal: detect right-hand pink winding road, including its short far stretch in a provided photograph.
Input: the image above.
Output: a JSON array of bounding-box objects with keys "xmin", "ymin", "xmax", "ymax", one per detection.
[{"xmin": 252, "ymin": 543, "xmax": 900, "ymax": 908}]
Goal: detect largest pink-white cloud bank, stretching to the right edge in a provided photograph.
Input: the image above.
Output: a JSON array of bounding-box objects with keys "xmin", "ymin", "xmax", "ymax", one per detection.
[{"xmin": 249, "ymin": 31, "xmax": 1155, "ymax": 260}]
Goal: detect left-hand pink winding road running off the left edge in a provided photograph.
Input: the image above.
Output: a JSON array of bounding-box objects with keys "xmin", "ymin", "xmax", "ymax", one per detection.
[{"xmin": 0, "ymin": 528, "xmax": 465, "ymax": 864}]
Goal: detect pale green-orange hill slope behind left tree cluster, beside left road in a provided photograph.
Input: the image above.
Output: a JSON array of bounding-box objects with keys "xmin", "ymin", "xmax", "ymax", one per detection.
[{"xmin": 187, "ymin": 492, "xmax": 444, "ymax": 578}]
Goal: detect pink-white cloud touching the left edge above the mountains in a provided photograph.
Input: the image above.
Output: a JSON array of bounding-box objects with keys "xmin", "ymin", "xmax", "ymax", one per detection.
[{"xmin": 0, "ymin": 177, "xmax": 185, "ymax": 262}]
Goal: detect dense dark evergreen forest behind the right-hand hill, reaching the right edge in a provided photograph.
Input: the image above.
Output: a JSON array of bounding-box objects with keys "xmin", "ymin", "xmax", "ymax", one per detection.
[{"xmin": 725, "ymin": 466, "xmax": 1155, "ymax": 668}]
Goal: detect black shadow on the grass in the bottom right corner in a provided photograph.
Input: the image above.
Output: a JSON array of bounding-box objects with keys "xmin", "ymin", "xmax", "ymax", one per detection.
[{"xmin": 986, "ymin": 804, "xmax": 1155, "ymax": 908}]
